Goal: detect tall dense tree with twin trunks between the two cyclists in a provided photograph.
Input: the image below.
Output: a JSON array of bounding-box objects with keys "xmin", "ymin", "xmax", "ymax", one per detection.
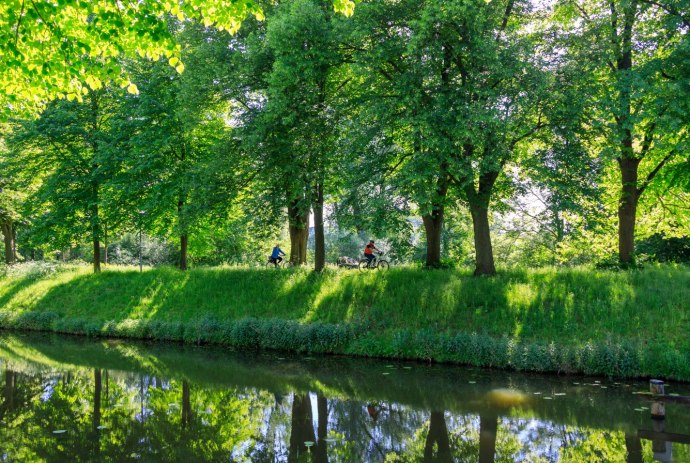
[{"xmin": 242, "ymin": 0, "xmax": 347, "ymax": 271}]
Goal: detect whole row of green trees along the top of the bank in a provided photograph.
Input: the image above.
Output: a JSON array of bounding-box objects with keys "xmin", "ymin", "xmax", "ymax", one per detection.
[{"xmin": 0, "ymin": 0, "xmax": 690, "ymax": 275}]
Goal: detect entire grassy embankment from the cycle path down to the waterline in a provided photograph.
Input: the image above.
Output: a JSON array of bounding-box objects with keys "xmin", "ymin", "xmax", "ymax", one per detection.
[{"xmin": 0, "ymin": 266, "xmax": 690, "ymax": 381}]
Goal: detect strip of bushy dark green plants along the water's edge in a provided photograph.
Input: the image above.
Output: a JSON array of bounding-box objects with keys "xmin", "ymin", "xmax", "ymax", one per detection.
[{"xmin": 0, "ymin": 311, "xmax": 690, "ymax": 382}]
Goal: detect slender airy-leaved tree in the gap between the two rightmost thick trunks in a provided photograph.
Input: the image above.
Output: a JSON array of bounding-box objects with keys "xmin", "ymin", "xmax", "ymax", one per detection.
[{"xmin": 509, "ymin": 67, "xmax": 604, "ymax": 264}]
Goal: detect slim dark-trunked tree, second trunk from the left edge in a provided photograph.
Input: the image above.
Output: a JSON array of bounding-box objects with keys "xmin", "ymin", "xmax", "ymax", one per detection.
[{"xmin": 9, "ymin": 90, "xmax": 115, "ymax": 272}]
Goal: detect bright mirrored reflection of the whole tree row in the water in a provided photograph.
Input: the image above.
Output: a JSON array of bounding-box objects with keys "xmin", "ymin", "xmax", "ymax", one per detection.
[{"xmin": 0, "ymin": 368, "xmax": 676, "ymax": 463}]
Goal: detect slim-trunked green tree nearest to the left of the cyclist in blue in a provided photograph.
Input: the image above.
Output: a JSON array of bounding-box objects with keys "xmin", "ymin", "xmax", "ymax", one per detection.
[{"xmin": 113, "ymin": 29, "xmax": 226, "ymax": 270}]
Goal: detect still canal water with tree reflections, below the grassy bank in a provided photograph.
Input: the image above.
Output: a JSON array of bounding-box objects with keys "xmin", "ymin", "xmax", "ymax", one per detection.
[{"xmin": 0, "ymin": 334, "xmax": 690, "ymax": 463}]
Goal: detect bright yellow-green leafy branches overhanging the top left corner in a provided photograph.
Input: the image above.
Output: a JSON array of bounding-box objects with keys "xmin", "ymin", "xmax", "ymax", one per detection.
[{"xmin": 0, "ymin": 0, "xmax": 354, "ymax": 119}]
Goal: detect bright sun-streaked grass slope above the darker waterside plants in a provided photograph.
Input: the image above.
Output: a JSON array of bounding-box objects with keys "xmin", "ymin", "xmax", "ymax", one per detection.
[{"xmin": 0, "ymin": 265, "xmax": 690, "ymax": 378}]
